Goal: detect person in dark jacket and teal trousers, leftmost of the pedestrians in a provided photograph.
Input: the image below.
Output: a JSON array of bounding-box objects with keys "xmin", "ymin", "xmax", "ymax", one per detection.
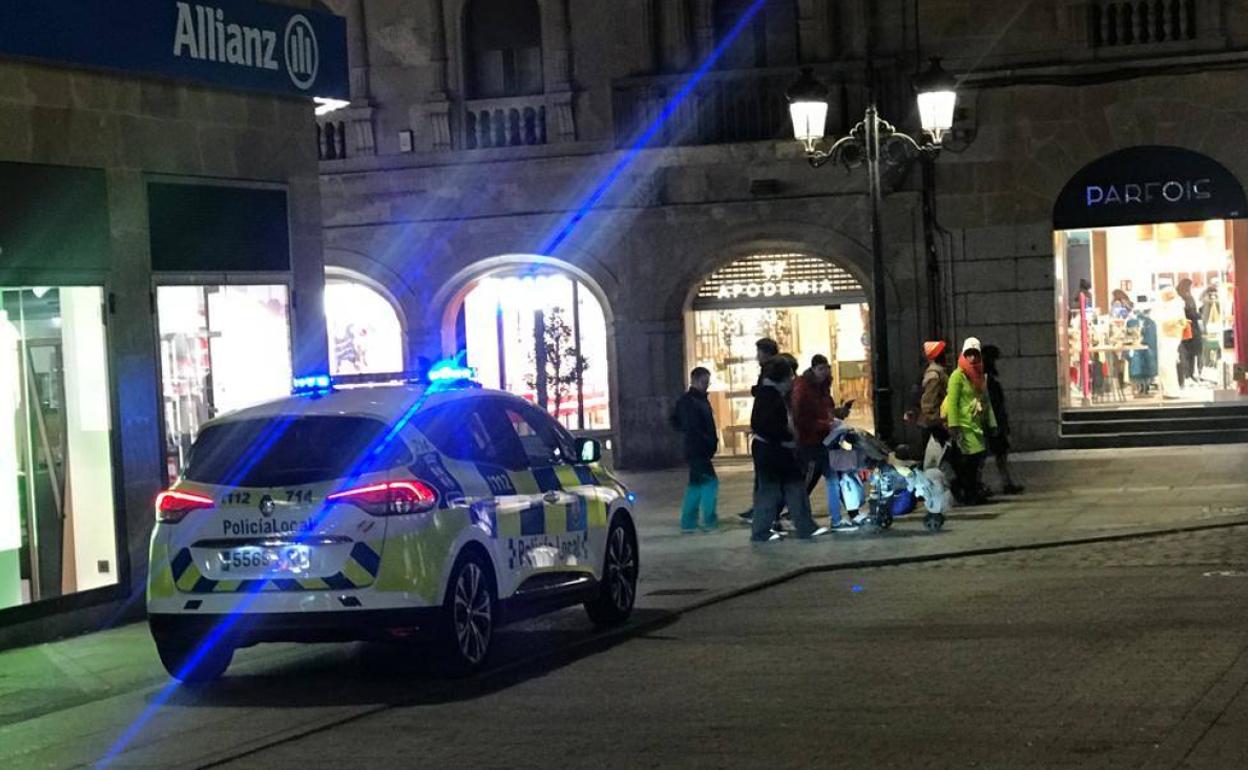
[{"xmin": 671, "ymin": 367, "xmax": 719, "ymax": 533}]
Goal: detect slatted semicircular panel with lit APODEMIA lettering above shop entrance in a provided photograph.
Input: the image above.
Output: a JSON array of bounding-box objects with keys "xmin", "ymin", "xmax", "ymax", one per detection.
[{"xmin": 694, "ymin": 253, "xmax": 865, "ymax": 309}]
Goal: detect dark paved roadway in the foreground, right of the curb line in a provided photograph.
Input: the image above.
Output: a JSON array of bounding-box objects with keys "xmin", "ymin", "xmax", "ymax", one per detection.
[{"xmin": 209, "ymin": 528, "xmax": 1248, "ymax": 770}]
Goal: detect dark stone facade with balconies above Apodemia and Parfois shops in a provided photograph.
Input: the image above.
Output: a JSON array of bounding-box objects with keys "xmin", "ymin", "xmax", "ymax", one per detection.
[{"xmin": 321, "ymin": 0, "xmax": 1248, "ymax": 467}]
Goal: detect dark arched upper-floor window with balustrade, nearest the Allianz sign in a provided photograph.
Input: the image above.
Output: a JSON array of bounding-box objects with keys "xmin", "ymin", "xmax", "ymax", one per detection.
[{"xmin": 464, "ymin": 0, "xmax": 544, "ymax": 99}]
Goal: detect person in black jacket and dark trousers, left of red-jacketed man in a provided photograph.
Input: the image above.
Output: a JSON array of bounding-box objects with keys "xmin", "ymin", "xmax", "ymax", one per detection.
[{"xmin": 750, "ymin": 358, "xmax": 827, "ymax": 543}]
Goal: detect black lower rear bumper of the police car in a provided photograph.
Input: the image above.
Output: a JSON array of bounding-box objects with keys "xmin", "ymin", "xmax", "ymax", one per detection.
[{"xmin": 147, "ymin": 607, "xmax": 442, "ymax": 646}]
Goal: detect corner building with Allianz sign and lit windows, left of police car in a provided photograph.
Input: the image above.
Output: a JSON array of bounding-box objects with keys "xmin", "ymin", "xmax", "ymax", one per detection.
[{"xmin": 0, "ymin": 0, "xmax": 349, "ymax": 648}]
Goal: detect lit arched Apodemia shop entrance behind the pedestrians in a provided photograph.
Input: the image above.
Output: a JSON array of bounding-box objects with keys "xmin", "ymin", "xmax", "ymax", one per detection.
[{"xmin": 685, "ymin": 252, "xmax": 874, "ymax": 456}]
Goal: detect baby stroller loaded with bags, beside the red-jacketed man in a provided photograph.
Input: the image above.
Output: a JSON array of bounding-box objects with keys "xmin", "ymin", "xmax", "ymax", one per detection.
[{"xmin": 824, "ymin": 423, "xmax": 950, "ymax": 532}]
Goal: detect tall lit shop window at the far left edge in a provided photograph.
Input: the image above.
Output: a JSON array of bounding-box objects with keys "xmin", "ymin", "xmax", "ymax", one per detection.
[{"xmin": 0, "ymin": 287, "xmax": 119, "ymax": 609}]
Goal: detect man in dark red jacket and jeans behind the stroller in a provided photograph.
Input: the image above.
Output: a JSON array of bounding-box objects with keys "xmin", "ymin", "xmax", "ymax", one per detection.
[{"xmin": 792, "ymin": 354, "xmax": 856, "ymax": 529}]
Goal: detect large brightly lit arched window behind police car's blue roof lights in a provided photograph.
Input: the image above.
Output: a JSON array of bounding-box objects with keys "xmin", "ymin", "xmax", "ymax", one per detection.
[{"xmin": 451, "ymin": 263, "xmax": 612, "ymax": 431}]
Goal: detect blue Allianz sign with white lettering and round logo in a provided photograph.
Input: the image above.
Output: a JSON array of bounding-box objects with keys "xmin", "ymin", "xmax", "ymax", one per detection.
[{"xmin": 0, "ymin": 0, "xmax": 349, "ymax": 99}]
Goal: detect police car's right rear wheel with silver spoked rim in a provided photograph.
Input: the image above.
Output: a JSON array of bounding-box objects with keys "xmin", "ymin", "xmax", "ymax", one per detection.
[{"xmin": 438, "ymin": 552, "xmax": 498, "ymax": 676}]
